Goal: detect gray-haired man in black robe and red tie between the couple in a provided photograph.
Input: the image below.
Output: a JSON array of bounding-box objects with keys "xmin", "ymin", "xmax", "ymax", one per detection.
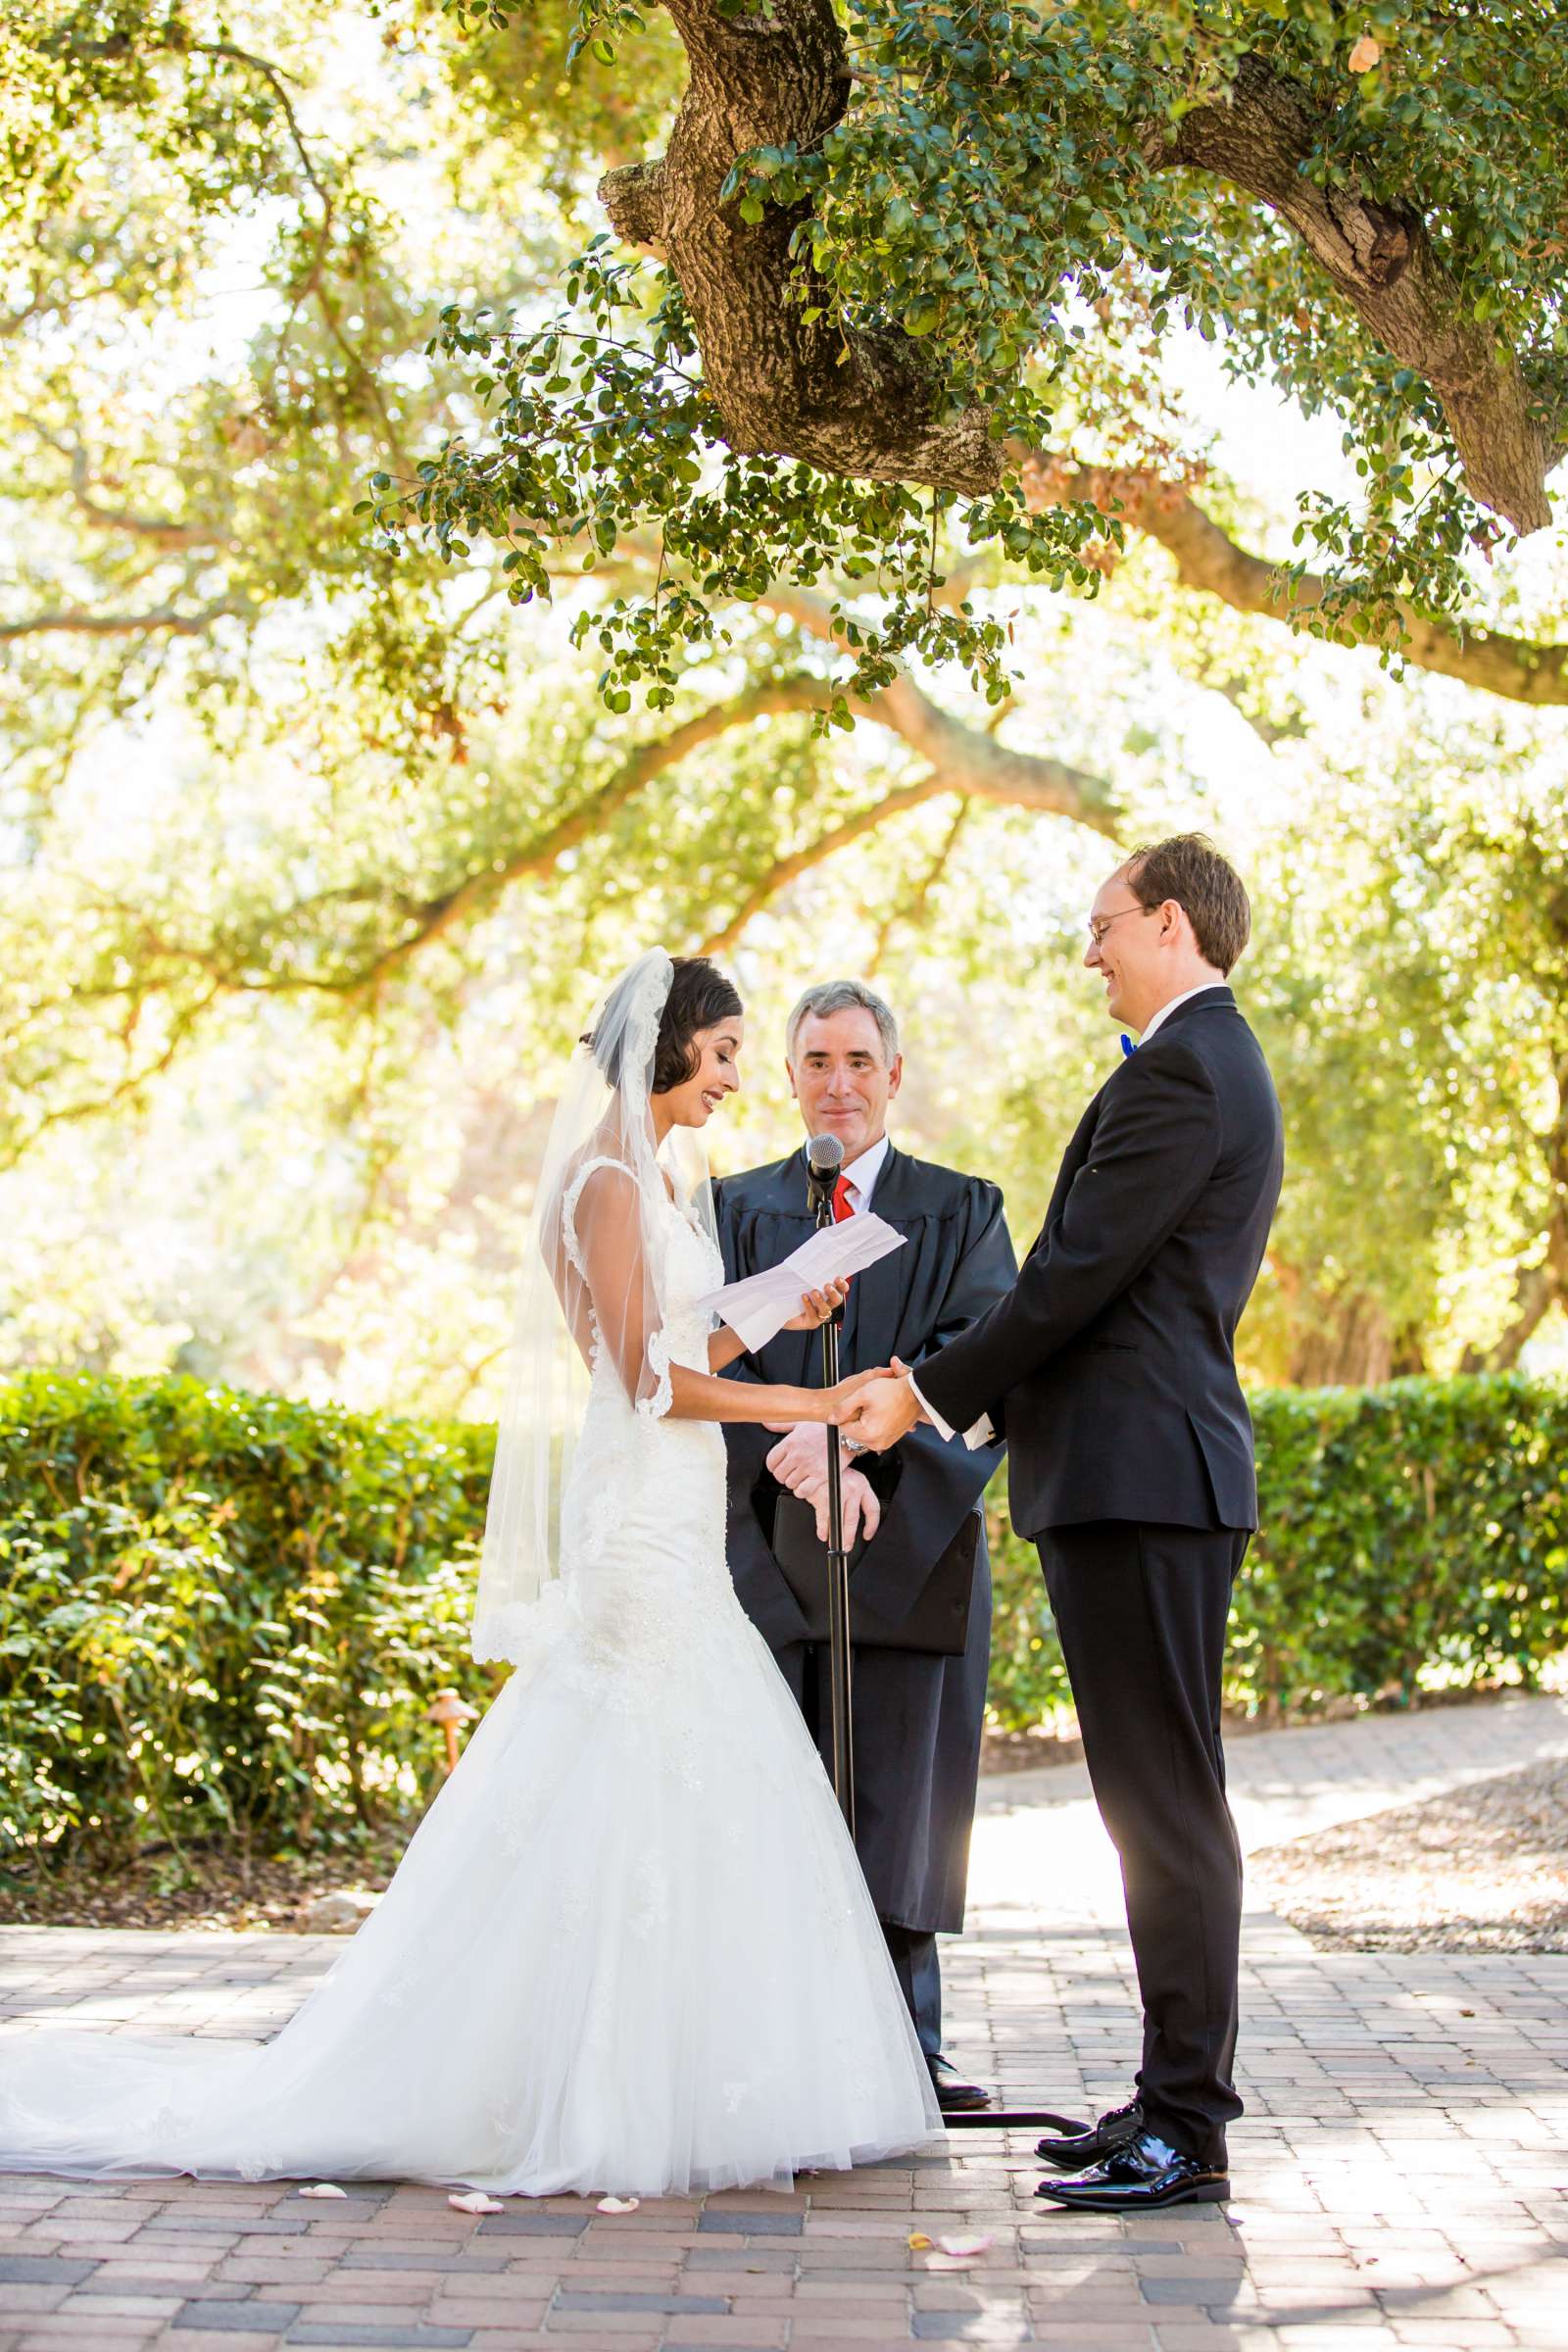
[{"xmin": 717, "ymin": 981, "xmax": 1015, "ymax": 2112}]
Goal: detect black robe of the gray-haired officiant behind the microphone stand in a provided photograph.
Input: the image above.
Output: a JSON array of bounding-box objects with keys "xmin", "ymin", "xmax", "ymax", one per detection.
[{"xmin": 717, "ymin": 1148, "xmax": 1015, "ymax": 1936}]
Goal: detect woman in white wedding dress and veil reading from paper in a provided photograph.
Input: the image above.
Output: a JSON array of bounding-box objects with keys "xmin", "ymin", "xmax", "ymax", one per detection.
[{"xmin": 0, "ymin": 951, "xmax": 938, "ymax": 2197}]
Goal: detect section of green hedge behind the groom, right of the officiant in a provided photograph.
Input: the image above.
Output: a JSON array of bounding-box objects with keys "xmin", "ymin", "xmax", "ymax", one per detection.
[{"xmin": 992, "ymin": 1374, "xmax": 1568, "ymax": 1729}]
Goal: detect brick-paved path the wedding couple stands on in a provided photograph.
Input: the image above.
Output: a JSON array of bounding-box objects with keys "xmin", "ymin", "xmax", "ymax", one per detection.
[{"xmin": 0, "ymin": 1700, "xmax": 1568, "ymax": 2352}]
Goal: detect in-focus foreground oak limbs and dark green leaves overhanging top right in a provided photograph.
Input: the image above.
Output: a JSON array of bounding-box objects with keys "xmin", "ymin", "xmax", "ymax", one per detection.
[{"xmin": 409, "ymin": 0, "xmax": 1568, "ymax": 717}]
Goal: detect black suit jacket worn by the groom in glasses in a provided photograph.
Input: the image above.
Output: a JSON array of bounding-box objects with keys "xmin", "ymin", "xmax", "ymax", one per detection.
[{"xmin": 919, "ymin": 988, "xmax": 1284, "ymax": 1536}]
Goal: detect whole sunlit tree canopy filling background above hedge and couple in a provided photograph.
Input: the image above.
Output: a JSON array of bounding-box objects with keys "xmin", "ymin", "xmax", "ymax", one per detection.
[{"xmin": 0, "ymin": 0, "xmax": 1568, "ymax": 1404}]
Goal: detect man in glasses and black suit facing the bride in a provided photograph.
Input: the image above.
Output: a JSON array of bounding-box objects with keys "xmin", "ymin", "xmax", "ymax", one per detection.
[{"xmin": 847, "ymin": 833, "xmax": 1284, "ymax": 2211}]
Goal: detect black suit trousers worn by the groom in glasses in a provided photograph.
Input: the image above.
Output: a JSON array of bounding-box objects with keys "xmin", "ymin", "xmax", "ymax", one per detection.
[{"xmin": 1039, "ymin": 1519, "xmax": 1249, "ymax": 2164}]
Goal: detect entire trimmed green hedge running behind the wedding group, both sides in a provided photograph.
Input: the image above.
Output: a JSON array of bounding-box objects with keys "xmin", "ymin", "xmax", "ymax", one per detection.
[{"xmin": 0, "ymin": 1374, "xmax": 1568, "ymax": 1853}]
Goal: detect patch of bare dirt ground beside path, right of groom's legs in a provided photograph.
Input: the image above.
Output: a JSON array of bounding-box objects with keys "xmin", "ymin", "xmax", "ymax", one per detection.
[{"xmin": 1246, "ymin": 1762, "xmax": 1568, "ymax": 1952}]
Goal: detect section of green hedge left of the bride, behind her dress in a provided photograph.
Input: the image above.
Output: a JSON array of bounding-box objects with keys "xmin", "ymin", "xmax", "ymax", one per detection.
[{"xmin": 0, "ymin": 1374, "xmax": 494, "ymax": 1853}]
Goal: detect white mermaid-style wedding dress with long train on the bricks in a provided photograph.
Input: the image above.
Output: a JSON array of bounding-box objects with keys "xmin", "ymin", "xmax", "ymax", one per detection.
[{"xmin": 0, "ymin": 1169, "xmax": 938, "ymax": 2197}]
